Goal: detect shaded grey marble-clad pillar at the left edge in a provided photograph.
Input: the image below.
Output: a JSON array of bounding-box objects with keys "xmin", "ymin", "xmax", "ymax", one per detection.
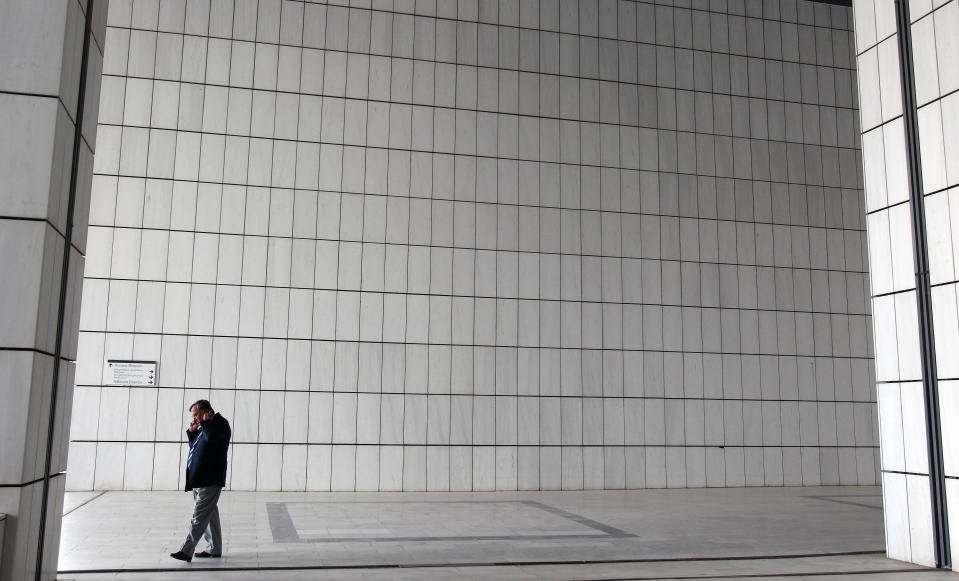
[{"xmin": 0, "ymin": 0, "xmax": 107, "ymax": 581}]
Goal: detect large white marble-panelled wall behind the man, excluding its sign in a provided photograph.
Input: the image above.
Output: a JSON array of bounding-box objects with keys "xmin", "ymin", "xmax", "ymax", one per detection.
[{"xmin": 68, "ymin": 0, "xmax": 878, "ymax": 490}]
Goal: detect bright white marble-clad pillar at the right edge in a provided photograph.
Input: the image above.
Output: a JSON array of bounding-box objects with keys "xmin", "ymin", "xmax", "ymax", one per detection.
[{"xmin": 855, "ymin": 0, "xmax": 959, "ymax": 565}]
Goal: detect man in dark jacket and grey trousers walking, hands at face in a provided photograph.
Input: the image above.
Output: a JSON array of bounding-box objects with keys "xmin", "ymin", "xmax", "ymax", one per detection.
[{"xmin": 170, "ymin": 399, "xmax": 230, "ymax": 563}]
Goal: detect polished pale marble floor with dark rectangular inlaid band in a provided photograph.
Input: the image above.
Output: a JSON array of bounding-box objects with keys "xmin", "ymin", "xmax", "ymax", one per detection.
[{"xmin": 58, "ymin": 487, "xmax": 959, "ymax": 581}]
